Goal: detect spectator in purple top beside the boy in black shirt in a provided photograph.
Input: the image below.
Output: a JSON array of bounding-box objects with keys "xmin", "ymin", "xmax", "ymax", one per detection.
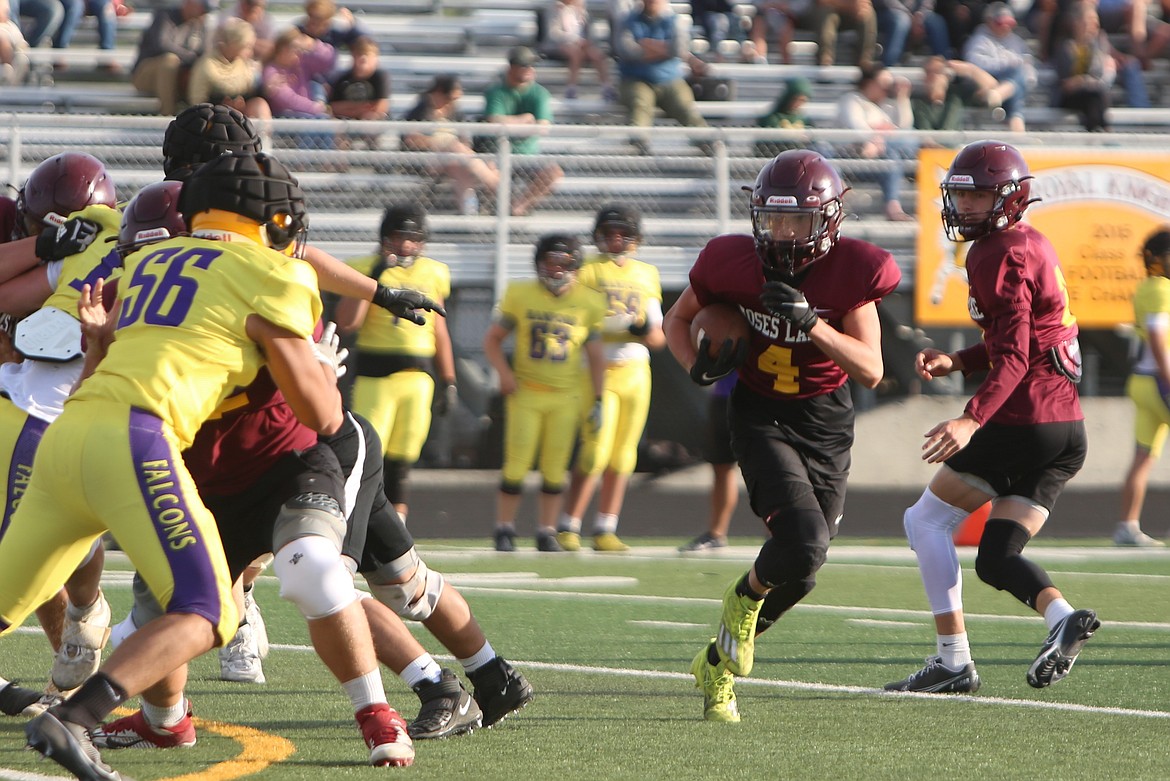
[{"xmin": 262, "ymin": 27, "xmax": 336, "ymax": 119}]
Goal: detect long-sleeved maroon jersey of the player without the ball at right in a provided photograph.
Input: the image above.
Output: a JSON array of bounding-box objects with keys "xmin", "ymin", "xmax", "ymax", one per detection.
[{"xmin": 959, "ymin": 222, "xmax": 1085, "ymax": 426}]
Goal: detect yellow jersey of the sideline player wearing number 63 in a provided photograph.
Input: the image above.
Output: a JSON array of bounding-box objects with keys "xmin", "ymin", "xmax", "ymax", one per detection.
[{"xmin": 500, "ymin": 279, "xmax": 606, "ymax": 391}]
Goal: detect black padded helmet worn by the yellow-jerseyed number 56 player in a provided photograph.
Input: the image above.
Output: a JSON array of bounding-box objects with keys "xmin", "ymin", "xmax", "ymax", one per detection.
[{"xmin": 179, "ymin": 152, "xmax": 309, "ymax": 257}]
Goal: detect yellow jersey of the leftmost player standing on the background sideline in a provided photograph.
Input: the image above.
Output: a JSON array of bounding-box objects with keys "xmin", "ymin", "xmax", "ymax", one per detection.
[{"xmin": 349, "ymin": 255, "xmax": 450, "ymax": 358}]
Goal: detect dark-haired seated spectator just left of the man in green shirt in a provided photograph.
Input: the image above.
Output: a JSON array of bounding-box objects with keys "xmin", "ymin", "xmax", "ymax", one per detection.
[{"xmin": 401, "ymin": 75, "xmax": 500, "ymax": 214}]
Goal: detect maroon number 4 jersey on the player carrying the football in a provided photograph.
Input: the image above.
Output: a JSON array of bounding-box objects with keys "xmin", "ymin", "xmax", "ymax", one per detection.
[{"xmin": 690, "ymin": 235, "xmax": 902, "ymax": 399}]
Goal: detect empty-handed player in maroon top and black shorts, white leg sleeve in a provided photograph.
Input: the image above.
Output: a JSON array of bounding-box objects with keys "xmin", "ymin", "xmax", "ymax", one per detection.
[{"xmin": 886, "ymin": 141, "xmax": 1100, "ymax": 692}]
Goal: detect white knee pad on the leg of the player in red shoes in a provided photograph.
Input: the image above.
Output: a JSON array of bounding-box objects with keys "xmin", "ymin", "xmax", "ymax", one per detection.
[{"xmin": 273, "ymin": 535, "xmax": 357, "ymax": 621}]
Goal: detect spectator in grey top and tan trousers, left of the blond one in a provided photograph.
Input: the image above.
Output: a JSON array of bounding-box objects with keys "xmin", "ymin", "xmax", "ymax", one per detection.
[{"xmin": 130, "ymin": 0, "xmax": 218, "ymax": 115}]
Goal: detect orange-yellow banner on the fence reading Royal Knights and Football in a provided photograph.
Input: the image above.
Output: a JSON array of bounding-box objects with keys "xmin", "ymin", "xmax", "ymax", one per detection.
[{"xmin": 914, "ymin": 148, "xmax": 1170, "ymax": 329}]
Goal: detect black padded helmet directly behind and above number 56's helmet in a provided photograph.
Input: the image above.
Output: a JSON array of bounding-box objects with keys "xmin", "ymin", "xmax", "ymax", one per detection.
[{"xmin": 163, "ymin": 103, "xmax": 260, "ymax": 181}]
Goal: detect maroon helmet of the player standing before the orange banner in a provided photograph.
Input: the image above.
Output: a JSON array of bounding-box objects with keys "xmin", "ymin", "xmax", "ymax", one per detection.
[{"xmin": 942, "ymin": 141, "xmax": 1040, "ymax": 241}]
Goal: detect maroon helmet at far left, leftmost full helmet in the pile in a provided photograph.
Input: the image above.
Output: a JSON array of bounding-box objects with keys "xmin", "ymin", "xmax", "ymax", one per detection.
[{"xmin": 16, "ymin": 152, "xmax": 117, "ymax": 236}]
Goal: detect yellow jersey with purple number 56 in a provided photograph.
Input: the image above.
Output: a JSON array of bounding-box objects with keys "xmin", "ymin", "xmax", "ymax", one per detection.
[{"xmin": 72, "ymin": 237, "xmax": 322, "ymax": 448}]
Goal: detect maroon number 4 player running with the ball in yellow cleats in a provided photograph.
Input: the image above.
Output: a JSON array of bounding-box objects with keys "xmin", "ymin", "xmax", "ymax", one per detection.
[{"xmin": 665, "ymin": 150, "xmax": 901, "ymax": 721}]
